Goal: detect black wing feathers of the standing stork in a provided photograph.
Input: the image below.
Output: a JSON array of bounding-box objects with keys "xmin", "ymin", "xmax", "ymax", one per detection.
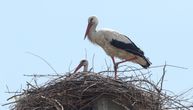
[{"xmin": 110, "ymin": 39, "xmax": 144, "ymax": 57}]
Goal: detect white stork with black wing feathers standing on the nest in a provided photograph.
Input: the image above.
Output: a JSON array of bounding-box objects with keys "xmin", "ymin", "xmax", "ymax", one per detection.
[{"xmin": 84, "ymin": 16, "xmax": 151, "ymax": 79}]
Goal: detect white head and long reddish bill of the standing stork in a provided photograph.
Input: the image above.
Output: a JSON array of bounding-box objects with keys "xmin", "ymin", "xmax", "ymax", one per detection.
[{"xmin": 84, "ymin": 16, "xmax": 98, "ymax": 39}]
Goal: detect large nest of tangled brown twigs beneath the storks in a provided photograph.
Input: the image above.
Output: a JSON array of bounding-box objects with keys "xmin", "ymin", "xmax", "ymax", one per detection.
[{"xmin": 6, "ymin": 72, "xmax": 193, "ymax": 110}]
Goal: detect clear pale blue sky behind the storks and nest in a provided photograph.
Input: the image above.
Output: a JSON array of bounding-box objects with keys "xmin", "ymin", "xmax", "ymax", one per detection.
[{"xmin": 0, "ymin": 0, "xmax": 193, "ymax": 110}]
